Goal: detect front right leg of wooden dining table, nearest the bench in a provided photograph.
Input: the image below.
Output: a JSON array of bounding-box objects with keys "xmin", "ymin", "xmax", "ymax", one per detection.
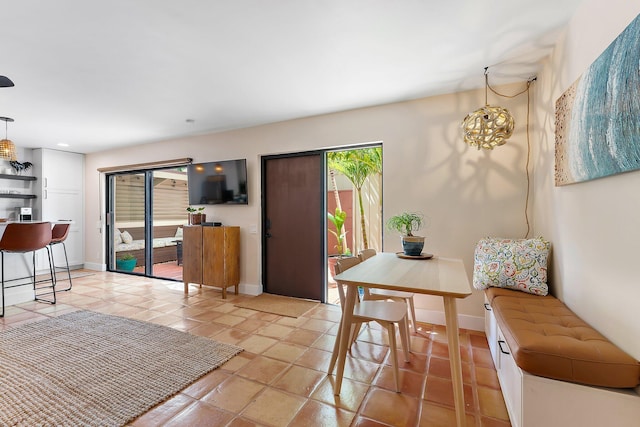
[{"xmin": 443, "ymin": 296, "xmax": 466, "ymax": 427}]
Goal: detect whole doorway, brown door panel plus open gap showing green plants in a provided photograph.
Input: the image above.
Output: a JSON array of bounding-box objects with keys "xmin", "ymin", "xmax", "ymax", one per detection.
[{"xmin": 262, "ymin": 143, "xmax": 382, "ymax": 304}]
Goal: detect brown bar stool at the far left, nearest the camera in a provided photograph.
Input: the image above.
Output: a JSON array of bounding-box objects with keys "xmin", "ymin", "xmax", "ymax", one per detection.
[{"xmin": 0, "ymin": 222, "xmax": 56, "ymax": 317}]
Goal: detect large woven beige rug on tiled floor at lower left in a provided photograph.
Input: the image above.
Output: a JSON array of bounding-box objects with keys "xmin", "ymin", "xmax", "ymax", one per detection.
[{"xmin": 0, "ymin": 311, "xmax": 242, "ymax": 426}]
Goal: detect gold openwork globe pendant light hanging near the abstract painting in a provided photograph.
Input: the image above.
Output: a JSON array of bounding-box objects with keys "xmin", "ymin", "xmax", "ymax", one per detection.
[{"xmin": 461, "ymin": 68, "xmax": 515, "ymax": 150}]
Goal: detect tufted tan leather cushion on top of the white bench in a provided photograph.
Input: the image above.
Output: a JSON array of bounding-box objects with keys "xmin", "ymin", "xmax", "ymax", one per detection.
[{"xmin": 488, "ymin": 289, "xmax": 640, "ymax": 388}]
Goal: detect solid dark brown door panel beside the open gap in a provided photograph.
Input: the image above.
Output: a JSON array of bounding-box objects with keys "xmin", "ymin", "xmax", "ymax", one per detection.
[{"xmin": 262, "ymin": 152, "xmax": 326, "ymax": 302}]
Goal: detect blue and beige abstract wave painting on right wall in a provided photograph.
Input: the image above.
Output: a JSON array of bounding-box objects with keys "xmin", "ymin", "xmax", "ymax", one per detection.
[{"xmin": 555, "ymin": 15, "xmax": 640, "ymax": 186}]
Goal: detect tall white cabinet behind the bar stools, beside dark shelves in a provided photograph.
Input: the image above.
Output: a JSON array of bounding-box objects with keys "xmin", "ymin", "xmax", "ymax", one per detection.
[{"xmin": 32, "ymin": 148, "xmax": 84, "ymax": 268}]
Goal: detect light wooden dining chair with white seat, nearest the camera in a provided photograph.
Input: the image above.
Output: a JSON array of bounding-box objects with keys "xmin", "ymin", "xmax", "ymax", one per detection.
[{"xmin": 329, "ymin": 257, "xmax": 410, "ymax": 392}]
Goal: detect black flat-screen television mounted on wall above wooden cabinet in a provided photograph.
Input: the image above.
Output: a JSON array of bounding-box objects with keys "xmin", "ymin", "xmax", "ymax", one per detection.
[{"xmin": 187, "ymin": 159, "xmax": 249, "ymax": 205}]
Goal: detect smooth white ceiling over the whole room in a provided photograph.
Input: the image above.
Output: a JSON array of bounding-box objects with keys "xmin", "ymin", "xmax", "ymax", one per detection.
[{"xmin": 0, "ymin": 0, "xmax": 582, "ymax": 153}]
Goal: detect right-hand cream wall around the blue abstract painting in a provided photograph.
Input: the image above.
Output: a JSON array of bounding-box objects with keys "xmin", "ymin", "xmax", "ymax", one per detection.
[{"xmin": 535, "ymin": 0, "xmax": 640, "ymax": 359}]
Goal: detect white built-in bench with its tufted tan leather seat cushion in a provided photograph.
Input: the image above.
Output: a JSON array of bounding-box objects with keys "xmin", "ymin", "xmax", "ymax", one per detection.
[{"xmin": 484, "ymin": 288, "xmax": 640, "ymax": 427}]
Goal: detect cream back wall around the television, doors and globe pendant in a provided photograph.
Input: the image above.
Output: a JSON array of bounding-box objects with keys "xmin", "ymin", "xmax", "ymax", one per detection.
[{"xmin": 86, "ymin": 77, "xmax": 526, "ymax": 329}]
